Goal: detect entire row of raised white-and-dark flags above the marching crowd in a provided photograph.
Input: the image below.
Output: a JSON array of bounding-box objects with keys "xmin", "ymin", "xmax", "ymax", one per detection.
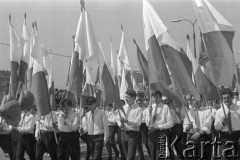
[{"xmin": 6, "ymin": 0, "xmax": 239, "ymax": 115}]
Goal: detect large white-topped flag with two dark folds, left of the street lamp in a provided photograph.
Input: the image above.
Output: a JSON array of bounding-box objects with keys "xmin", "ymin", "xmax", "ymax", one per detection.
[{"xmin": 143, "ymin": 0, "xmax": 196, "ymax": 100}]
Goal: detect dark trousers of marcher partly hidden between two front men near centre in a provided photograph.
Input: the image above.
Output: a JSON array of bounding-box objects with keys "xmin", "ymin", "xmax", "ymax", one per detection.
[{"xmin": 106, "ymin": 126, "xmax": 119, "ymax": 159}]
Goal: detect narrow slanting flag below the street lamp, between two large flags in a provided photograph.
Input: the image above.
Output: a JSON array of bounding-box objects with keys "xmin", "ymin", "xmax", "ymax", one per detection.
[{"xmin": 187, "ymin": 40, "xmax": 219, "ymax": 101}]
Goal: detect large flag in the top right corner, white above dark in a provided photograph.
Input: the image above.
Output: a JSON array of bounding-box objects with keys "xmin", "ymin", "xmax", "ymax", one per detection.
[{"xmin": 194, "ymin": 0, "xmax": 235, "ymax": 87}]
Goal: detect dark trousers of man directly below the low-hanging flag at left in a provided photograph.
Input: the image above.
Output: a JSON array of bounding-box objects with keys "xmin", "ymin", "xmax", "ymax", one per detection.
[{"xmin": 36, "ymin": 132, "xmax": 57, "ymax": 160}]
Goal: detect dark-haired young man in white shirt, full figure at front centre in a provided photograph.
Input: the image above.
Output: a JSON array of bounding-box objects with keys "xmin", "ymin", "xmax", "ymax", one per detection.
[{"xmin": 117, "ymin": 90, "xmax": 142, "ymax": 160}]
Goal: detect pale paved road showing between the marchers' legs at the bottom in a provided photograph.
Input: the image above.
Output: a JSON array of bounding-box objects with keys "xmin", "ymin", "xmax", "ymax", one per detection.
[{"xmin": 5, "ymin": 143, "xmax": 150, "ymax": 160}]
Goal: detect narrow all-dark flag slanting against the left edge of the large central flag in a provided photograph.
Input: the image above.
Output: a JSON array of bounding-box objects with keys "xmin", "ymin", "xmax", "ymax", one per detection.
[{"xmin": 134, "ymin": 40, "xmax": 148, "ymax": 86}]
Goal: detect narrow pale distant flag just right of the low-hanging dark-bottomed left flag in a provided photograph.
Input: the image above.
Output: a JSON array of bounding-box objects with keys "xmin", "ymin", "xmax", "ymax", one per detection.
[{"xmin": 43, "ymin": 54, "xmax": 57, "ymax": 111}]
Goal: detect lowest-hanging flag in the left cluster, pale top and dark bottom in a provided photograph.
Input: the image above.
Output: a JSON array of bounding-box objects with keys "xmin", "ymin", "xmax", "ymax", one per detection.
[{"xmin": 31, "ymin": 37, "xmax": 50, "ymax": 116}]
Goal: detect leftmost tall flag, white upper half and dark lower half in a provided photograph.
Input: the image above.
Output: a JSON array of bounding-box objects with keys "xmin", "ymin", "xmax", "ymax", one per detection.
[{"xmin": 9, "ymin": 15, "xmax": 22, "ymax": 97}]
